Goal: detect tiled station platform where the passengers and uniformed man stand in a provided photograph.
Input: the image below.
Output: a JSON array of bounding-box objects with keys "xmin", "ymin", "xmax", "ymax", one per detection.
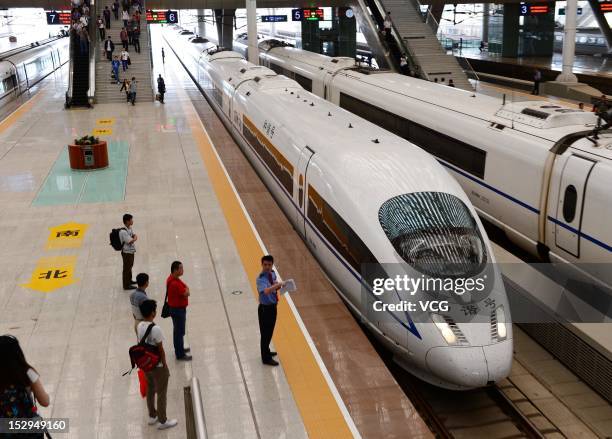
[{"xmin": 0, "ymin": 35, "xmax": 432, "ymax": 439}]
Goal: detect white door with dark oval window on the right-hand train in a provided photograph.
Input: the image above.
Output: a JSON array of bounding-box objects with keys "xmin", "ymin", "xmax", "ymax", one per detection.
[{"xmin": 555, "ymin": 155, "xmax": 595, "ymax": 258}]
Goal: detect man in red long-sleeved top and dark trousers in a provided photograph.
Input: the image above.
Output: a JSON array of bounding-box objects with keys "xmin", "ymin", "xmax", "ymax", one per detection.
[{"xmin": 166, "ymin": 261, "xmax": 191, "ymax": 361}]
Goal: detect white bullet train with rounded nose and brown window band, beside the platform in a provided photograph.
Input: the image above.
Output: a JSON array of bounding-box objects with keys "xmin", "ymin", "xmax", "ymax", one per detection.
[{"xmin": 165, "ymin": 31, "xmax": 513, "ymax": 389}]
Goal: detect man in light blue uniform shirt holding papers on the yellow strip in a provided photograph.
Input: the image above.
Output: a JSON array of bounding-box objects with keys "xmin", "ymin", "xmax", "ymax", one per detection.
[{"xmin": 256, "ymin": 255, "xmax": 283, "ymax": 366}]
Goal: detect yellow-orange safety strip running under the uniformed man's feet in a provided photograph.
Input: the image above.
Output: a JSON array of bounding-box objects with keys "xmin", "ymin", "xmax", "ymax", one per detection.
[{"xmin": 179, "ymin": 102, "xmax": 358, "ymax": 438}]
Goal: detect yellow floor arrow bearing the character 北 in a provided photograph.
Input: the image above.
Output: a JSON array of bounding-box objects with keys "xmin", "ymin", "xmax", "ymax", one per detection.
[{"xmin": 21, "ymin": 256, "xmax": 78, "ymax": 293}]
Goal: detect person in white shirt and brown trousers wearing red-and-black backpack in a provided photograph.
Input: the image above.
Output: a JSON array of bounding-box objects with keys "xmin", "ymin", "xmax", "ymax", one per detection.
[{"xmin": 136, "ymin": 300, "xmax": 178, "ymax": 430}]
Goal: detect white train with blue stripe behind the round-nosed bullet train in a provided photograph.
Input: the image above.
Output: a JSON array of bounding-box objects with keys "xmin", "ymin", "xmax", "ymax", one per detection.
[{"xmin": 260, "ymin": 40, "xmax": 612, "ymax": 290}]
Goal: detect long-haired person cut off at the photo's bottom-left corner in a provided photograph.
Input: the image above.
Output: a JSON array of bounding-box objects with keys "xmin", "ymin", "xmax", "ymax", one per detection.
[{"xmin": 0, "ymin": 335, "xmax": 50, "ymax": 428}]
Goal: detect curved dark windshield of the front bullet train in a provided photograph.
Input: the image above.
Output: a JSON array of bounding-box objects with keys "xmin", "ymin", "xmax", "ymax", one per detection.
[{"xmin": 378, "ymin": 192, "xmax": 487, "ymax": 277}]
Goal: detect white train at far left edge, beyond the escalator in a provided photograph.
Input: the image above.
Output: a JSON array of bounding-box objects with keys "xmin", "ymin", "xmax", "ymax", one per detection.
[{"xmin": 0, "ymin": 38, "xmax": 70, "ymax": 102}]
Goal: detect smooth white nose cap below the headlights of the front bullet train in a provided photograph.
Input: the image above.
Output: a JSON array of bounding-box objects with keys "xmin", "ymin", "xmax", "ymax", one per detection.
[{"xmin": 425, "ymin": 340, "xmax": 512, "ymax": 388}]
